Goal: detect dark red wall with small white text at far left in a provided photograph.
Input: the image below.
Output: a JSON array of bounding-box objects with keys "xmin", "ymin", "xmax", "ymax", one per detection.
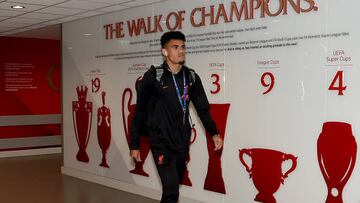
[{"xmin": 0, "ymin": 37, "xmax": 61, "ymax": 138}]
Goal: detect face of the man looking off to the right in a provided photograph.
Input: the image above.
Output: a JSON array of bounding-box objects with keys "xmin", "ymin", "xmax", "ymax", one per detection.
[{"xmin": 162, "ymin": 39, "xmax": 186, "ymax": 65}]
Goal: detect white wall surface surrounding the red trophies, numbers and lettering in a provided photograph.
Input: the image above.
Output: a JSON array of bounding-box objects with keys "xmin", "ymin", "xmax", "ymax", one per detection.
[{"xmin": 63, "ymin": 0, "xmax": 360, "ymax": 203}]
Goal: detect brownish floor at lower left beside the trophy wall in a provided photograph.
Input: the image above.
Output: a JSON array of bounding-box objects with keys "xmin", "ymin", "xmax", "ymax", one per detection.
[{"xmin": 0, "ymin": 154, "xmax": 158, "ymax": 203}]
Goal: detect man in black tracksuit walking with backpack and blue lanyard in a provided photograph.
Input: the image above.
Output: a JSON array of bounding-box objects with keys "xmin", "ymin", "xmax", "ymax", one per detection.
[{"xmin": 129, "ymin": 31, "xmax": 223, "ymax": 203}]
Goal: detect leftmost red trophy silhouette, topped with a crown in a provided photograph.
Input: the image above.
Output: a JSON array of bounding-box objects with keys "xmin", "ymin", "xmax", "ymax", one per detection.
[{"xmin": 72, "ymin": 86, "xmax": 92, "ymax": 162}]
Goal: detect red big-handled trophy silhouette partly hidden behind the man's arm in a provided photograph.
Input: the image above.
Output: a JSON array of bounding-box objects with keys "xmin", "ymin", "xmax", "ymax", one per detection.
[{"xmin": 122, "ymin": 88, "xmax": 150, "ymax": 177}]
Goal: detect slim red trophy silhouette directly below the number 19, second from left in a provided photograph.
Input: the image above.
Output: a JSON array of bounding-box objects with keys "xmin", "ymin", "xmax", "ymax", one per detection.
[{"xmin": 97, "ymin": 92, "xmax": 111, "ymax": 168}]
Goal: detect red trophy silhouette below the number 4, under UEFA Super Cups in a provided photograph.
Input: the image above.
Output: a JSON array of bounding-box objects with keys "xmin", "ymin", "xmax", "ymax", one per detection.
[{"xmin": 317, "ymin": 122, "xmax": 357, "ymax": 203}]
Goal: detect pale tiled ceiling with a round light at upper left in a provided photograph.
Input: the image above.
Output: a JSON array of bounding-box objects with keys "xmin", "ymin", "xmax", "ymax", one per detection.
[{"xmin": 0, "ymin": 0, "xmax": 164, "ymax": 39}]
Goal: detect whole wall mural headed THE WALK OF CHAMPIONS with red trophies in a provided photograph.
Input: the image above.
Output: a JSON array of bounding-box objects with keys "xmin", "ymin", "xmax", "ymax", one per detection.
[{"xmin": 62, "ymin": 0, "xmax": 360, "ymax": 203}]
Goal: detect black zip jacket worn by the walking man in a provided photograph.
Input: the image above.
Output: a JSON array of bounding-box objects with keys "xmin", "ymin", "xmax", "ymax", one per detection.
[{"xmin": 129, "ymin": 62, "xmax": 218, "ymax": 151}]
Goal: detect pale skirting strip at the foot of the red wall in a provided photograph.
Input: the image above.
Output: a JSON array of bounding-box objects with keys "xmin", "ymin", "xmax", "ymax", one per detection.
[{"xmin": 0, "ymin": 147, "xmax": 62, "ymax": 158}]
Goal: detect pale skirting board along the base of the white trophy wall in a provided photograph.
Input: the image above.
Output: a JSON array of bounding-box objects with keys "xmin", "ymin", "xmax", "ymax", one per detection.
[{"xmin": 61, "ymin": 166, "xmax": 204, "ymax": 203}]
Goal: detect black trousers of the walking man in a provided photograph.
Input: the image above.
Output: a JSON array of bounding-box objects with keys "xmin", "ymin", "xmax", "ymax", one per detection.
[{"xmin": 152, "ymin": 149, "xmax": 189, "ymax": 203}]
